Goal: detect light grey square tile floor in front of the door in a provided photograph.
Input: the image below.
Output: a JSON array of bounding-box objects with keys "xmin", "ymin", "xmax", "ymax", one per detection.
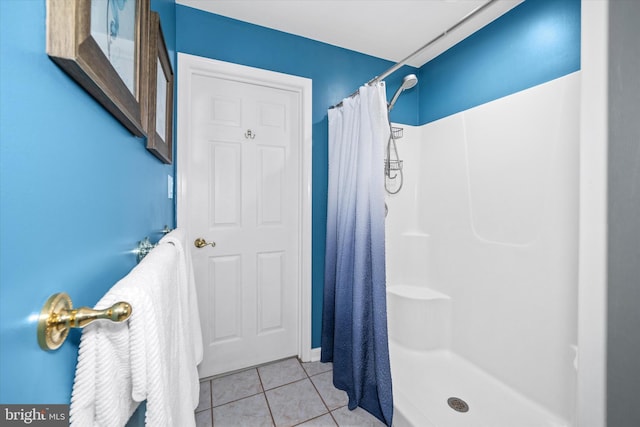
[{"xmin": 196, "ymin": 358, "xmax": 384, "ymax": 427}]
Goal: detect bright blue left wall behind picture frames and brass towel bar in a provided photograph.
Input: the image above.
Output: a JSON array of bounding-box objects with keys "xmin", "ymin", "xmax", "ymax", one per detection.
[{"xmin": 0, "ymin": 0, "xmax": 176, "ymax": 403}]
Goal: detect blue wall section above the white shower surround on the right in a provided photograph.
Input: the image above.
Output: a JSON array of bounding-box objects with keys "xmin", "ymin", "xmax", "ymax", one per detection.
[{"xmin": 418, "ymin": 0, "xmax": 580, "ymax": 124}]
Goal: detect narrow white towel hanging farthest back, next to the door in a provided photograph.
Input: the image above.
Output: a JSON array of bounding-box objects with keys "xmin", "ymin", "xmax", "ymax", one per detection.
[{"xmin": 160, "ymin": 228, "xmax": 203, "ymax": 411}]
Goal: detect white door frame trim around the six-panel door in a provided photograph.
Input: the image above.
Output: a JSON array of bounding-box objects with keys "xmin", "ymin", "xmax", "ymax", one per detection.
[{"xmin": 176, "ymin": 52, "xmax": 312, "ymax": 362}]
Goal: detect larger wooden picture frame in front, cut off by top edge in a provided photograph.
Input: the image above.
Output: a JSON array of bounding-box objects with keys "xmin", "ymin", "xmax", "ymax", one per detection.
[{"xmin": 47, "ymin": 0, "xmax": 150, "ymax": 137}]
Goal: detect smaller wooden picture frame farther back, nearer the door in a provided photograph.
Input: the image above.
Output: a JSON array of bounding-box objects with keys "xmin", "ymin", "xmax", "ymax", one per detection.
[{"xmin": 144, "ymin": 12, "xmax": 174, "ymax": 164}]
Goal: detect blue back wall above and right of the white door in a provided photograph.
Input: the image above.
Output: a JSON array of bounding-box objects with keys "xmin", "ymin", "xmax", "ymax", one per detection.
[{"xmin": 176, "ymin": 5, "xmax": 417, "ymax": 347}]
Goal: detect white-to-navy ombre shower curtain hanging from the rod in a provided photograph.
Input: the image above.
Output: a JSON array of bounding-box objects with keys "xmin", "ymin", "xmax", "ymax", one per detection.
[{"xmin": 321, "ymin": 82, "xmax": 393, "ymax": 426}]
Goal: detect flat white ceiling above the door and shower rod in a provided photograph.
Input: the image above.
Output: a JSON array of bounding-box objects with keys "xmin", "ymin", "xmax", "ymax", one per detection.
[{"xmin": 176, "ymin": 0, "xmax": 524, "ymax": 67}]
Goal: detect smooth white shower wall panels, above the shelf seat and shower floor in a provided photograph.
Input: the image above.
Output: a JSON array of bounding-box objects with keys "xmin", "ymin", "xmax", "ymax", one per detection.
[{"xmin": 387, "ymin": 73, "xmax": 580, "ymax": 420}]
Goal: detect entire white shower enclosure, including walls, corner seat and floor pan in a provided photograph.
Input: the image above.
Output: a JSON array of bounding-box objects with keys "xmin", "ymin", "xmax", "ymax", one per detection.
[{"xmin": 386, "ymin": 72, "xmax": 581, "ymax": 427}]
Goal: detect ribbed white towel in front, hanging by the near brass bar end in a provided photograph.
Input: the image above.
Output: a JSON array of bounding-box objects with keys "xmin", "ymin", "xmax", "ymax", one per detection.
[{"xmin": 70, "ymin": 243, "xmax": 195, "ymax": 427}]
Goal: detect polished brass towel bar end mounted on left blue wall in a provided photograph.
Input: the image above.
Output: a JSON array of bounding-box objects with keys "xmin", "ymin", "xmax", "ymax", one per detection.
[{"xmin": 38, "ymin": 292, "xmax": 132, "ymax": 350}]
